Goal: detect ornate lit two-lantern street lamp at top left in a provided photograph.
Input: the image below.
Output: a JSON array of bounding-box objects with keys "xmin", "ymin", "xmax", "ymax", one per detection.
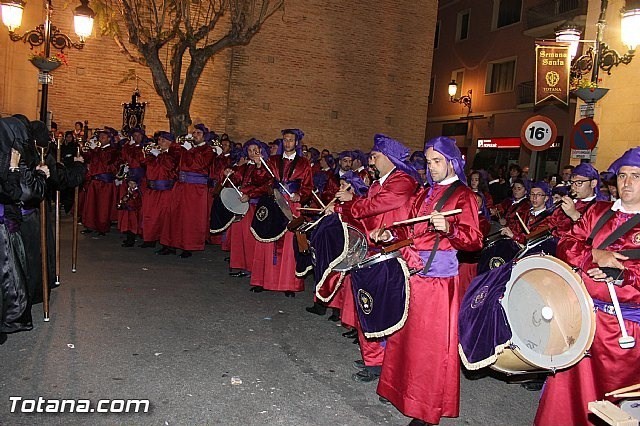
[{"xmin": 0, "ymin": 0, "xmax": 95, "ymax": 123}]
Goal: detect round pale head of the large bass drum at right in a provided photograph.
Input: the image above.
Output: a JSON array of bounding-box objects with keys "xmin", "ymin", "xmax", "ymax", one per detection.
[{"xmin": 496, "ymin": 255, "xmax": 595, "ymax": 373}]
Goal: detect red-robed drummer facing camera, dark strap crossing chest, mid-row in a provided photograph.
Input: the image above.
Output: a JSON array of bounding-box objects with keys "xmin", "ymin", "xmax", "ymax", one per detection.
[{"xmin": 250, "ymin": 129, "xmax": 313, "ymax": 297}]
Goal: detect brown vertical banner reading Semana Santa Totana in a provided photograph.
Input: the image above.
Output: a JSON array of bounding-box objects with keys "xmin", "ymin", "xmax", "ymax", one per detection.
[{"xmin": 535, "ymin": 41, "xmax": 571, "ymax": 105}]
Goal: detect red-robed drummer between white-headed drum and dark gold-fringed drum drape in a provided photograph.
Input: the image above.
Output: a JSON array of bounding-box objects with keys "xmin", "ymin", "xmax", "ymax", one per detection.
[{"xmin": 224, "ymin": 139, "xmax": 273, "ymax": 277}]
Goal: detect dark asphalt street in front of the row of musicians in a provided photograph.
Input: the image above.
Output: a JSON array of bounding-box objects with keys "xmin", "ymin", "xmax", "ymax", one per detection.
[{"xmin": 0, "ymin": 216, "xmax": 539, "ymax": 425}]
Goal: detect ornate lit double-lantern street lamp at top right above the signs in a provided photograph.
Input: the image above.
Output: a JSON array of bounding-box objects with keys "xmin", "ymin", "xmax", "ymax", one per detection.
[{"xmin": 556, "ymin": 0, "xmax": 640, "ymax": 84}]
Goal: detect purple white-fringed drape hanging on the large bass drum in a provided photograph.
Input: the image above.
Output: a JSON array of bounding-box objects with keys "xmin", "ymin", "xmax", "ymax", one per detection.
[{"xmin": 458, "ymin": 262, "xmax": 513, "ymax": 370}]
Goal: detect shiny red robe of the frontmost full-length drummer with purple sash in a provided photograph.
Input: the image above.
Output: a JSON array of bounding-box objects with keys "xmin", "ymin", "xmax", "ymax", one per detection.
[{"xmin": 378, "ymin": 178, "xmax": 482, "ymax": 424}]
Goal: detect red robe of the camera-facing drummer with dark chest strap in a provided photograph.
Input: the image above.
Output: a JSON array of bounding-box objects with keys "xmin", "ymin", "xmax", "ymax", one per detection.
[{"xmin": 251, "ymin": 155, "xmax": 313, "ymax": 291}]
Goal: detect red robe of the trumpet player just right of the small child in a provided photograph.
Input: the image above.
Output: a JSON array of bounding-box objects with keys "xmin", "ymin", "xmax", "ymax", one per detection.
[{"xmin": 142, "ymin": 144, "xmax": 180, "ymax": 241}]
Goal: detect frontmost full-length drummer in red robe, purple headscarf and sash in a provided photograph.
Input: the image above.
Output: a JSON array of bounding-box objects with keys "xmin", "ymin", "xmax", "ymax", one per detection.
[{"xmin": 374, "ymin": 137, "xmax": 482, "ymax": 425}]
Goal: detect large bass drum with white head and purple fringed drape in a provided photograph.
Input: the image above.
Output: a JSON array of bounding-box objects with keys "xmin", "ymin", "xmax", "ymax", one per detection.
[{"xmin": 459, "ymin": 254, "xmax": 596, "ymax": 374}]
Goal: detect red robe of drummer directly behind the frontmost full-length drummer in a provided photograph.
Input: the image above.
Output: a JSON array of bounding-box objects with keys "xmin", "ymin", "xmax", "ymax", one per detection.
[{"xmin": 335, "ymin": 169, "xmax": 421, "ymax": 366}]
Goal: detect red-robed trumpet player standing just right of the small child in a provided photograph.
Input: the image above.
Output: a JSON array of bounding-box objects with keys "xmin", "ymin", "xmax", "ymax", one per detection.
[{"xmin": 140, "ymin": 132, "xmax": 180, "ymax": 248}]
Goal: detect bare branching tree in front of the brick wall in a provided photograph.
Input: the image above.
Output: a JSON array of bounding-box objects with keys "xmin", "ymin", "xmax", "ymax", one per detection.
[{"xmin": 92, "ymin": 0, "xmax": 284, "ymax": 134}]
